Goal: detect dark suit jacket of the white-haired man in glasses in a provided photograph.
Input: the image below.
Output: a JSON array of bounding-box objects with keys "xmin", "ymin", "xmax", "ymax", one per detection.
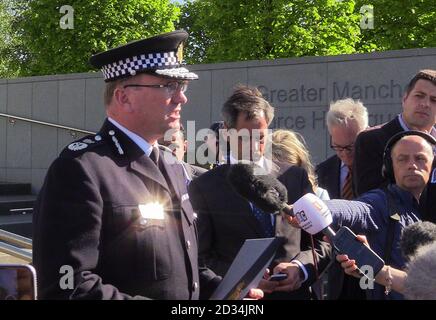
[{"xmin": 316, "ymin": 155, "xmax": 341, "ymax": 199}]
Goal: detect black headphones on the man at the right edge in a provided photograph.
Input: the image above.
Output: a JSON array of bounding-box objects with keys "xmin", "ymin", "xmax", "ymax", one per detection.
[{"xmin": 382, "ymin": 130, "xmax": 436, "ymax": 183}]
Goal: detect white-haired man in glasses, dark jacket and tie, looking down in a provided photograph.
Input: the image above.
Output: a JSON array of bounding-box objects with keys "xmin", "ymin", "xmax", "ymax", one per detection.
[{"xmin": 316, "ymin": 98, "xmax": 368, "ymax": 199}]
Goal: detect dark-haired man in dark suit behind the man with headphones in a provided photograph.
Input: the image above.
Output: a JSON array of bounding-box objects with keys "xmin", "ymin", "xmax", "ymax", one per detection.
[{"xmin": 353, "ymin": 69, "xmax": 436, "ymax": 222}]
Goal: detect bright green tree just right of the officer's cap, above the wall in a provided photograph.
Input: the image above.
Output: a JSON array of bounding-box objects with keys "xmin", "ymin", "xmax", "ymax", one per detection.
[{"xmin": 179, "ymin": 0, "xmax": 361, "ymax": 63}]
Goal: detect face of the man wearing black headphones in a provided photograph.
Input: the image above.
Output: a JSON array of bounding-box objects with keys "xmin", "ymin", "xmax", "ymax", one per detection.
[{"xmin": 391, "ymin": 136, "xmax": 433, "ymax": 194}]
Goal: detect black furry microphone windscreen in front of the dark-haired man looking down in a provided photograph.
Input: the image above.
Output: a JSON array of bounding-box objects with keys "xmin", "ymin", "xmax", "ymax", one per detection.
[{"xmin": 227, "ymin": 163, "xmax": 288, "ymax": 213}]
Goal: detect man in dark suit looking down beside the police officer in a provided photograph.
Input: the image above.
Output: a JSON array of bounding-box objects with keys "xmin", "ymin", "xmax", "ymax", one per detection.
[{"xmin": 189, "ymin": 86, "xmax": 329, "ymax": 299}]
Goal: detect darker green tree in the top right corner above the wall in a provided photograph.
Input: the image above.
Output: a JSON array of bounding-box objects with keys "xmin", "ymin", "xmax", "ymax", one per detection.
[{"xmin": 359, "ymin": 0, "xmax": 436, "ymax": 51}]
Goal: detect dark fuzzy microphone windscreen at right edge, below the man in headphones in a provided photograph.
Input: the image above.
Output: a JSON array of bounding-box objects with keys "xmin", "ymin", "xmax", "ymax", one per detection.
[{"xmin": 400, "ymin": 221, "xmax": 436, "ymax": 260}]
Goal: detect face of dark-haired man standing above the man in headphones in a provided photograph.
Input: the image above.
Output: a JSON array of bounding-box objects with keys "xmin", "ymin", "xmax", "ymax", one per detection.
[{"xmin": 403, "ymin": 80, "xmax": 436, "ymax": 131}]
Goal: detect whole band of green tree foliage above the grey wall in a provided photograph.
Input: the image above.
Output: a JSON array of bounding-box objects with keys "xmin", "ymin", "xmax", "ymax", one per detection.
[{"xmin": 0, "ymin": 0, "xmax": 436, "ymax": 77}]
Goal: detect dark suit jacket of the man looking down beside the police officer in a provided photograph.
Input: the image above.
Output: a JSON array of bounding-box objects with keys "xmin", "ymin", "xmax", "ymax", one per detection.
[{"xmin": 189, "ymin": 164, "xmax": 330, "ymax": 298}]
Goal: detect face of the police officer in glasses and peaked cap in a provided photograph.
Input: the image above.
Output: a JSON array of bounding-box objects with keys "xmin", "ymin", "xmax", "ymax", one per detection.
[{"xmin": 125, "ymin": 74, "xmax": 188, "ymax": 140}]
